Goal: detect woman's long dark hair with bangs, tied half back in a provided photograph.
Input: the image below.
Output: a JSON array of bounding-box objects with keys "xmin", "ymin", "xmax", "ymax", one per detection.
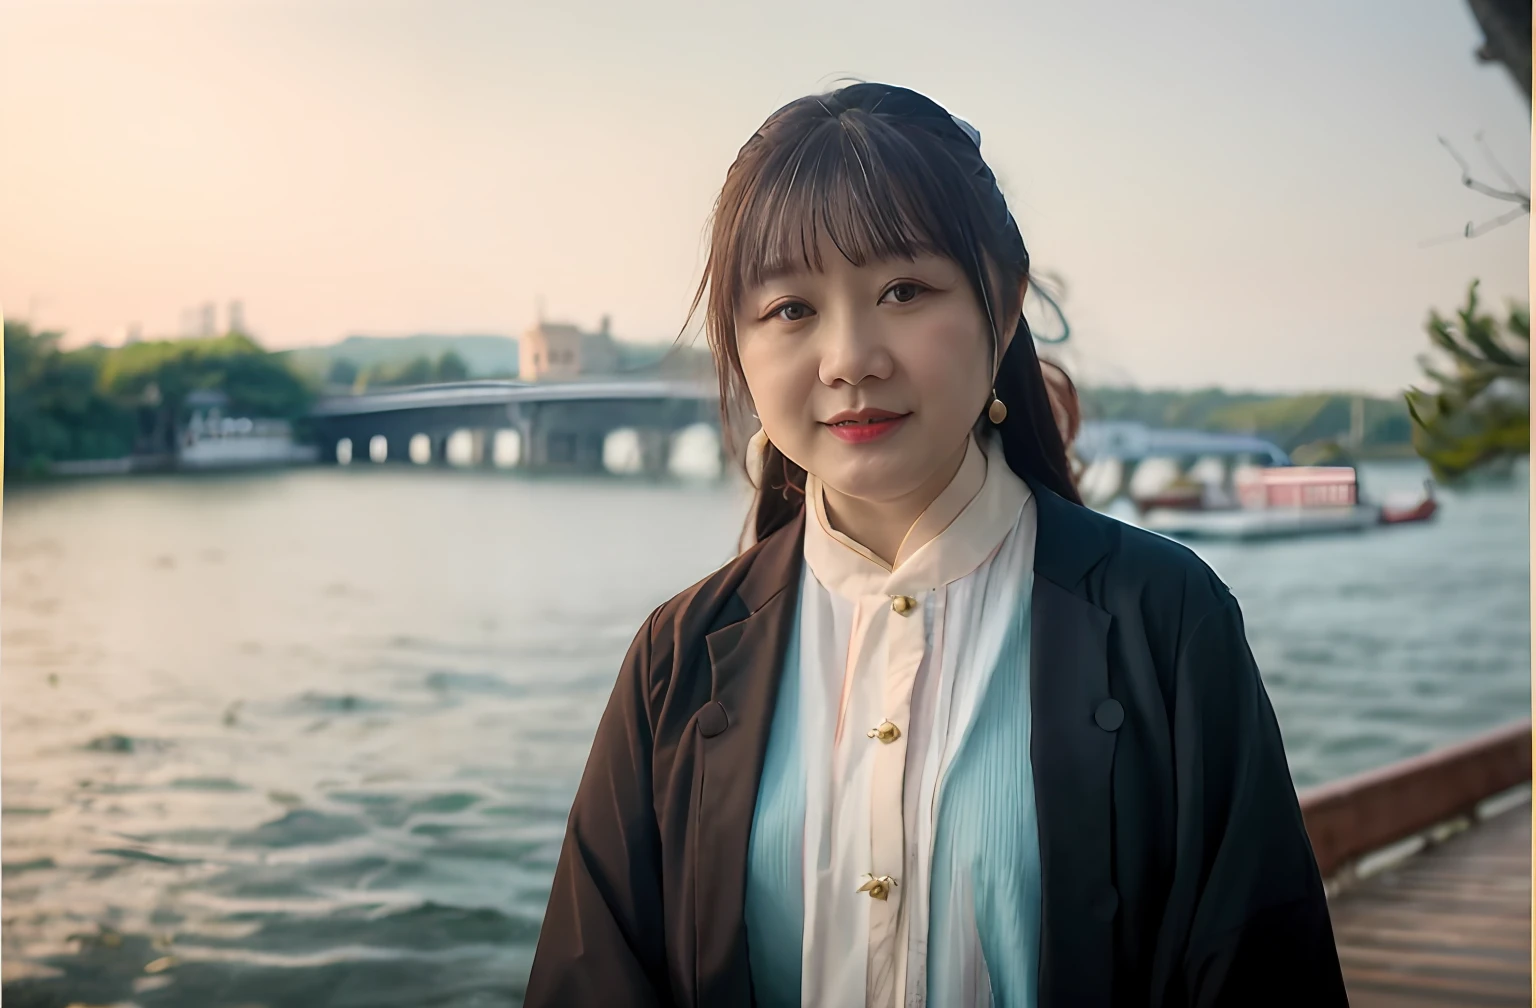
[{"xmin": 691, "ymin": 83, "xmax": 1081, "ymax": 541}]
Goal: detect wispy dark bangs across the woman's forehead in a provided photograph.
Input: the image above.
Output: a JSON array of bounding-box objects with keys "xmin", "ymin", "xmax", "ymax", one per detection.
[{"xmin": 716, "ymin": 114, "xmax": 975, "ymax": 304}]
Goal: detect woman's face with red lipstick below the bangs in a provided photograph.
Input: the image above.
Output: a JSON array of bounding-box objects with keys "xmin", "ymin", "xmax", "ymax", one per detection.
[{"xmin": 736, "ymin": 243, "xmax": 1011, "ymax": 502}]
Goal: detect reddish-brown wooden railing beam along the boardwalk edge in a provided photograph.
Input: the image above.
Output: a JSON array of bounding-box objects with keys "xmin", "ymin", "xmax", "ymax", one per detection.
[{"xmin": 1299, "ymin": 719, "xmax": 1531, "ymax": 877}]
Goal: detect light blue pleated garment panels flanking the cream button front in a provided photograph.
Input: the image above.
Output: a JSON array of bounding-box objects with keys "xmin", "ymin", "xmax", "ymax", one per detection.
[{"xmin": 745, "ymin": 585, "xmax": 1040, "ymax": 1008}]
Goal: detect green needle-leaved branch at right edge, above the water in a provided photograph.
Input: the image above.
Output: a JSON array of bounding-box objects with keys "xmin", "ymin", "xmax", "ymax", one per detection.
[{"xmin": 1405, "ymin": 280, "xmax": 1531, "ymax": 481}]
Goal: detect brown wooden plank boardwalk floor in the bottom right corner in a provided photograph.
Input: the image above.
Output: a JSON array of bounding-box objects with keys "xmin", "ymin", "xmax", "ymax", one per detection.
[{"xmin": 1332, "ymin": 802, "xmax": 1531, "ymax": 1008}]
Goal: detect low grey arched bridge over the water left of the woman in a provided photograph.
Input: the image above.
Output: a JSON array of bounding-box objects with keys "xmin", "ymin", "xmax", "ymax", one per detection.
[{"xmin": 309, "ymin": 378, "xmax": 719, "ymax": 473}]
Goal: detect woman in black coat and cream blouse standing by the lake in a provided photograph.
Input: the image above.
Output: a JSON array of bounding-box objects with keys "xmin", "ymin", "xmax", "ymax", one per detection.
[{"xmin": 527, "ymin": 85, "xmax": 1344, "ymax": 1008}]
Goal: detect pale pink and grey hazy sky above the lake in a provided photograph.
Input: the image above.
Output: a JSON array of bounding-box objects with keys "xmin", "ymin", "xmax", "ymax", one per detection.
[{"xmin": 0, "ymin": 0, "xmax": 1530, "ymax": 392}]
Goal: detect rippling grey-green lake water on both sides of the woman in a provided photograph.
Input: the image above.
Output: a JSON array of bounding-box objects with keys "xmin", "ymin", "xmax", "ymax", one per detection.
[{"xmin": 0, "ymin": 464, "xmax": 1530, "ymax": 1008}]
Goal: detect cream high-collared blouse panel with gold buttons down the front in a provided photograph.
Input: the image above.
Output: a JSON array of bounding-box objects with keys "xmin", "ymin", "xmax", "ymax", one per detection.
[{"xmin": 799, "ymin": 438, "xmax": 1035, "ymax": 1008}]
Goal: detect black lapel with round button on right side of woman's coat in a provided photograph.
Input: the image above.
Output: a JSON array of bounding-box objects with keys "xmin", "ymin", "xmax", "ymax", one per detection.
[{"xmin": 1029, "ymin": 484, "xmax": 1123, "ymax": 1005}]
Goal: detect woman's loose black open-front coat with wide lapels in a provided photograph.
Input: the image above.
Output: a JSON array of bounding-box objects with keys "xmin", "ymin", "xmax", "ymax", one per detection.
[{"xmin": 527, "ymin": 486, "xmax": 1347, "ymax": 1008}]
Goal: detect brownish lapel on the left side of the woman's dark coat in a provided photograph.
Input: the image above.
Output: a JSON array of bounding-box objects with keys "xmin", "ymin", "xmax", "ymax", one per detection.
[{"xmin": 693, "ymin": 510, "xmax": 805, "ymax": 1005}]
